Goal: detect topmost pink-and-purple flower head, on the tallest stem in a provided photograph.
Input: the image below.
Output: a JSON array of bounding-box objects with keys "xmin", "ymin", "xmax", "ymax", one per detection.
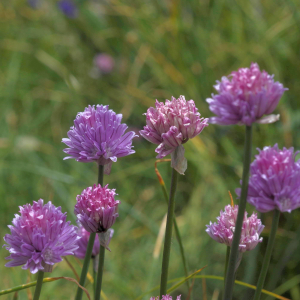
[{"xmin": 206, "ymin": 63, "xmax": 287, "ymax": 126}]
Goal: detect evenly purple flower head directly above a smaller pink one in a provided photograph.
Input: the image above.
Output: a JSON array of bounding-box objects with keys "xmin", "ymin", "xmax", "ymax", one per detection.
[{"xmin": 62, "ymin": 105, "xmax": 136, "ymax": 174}]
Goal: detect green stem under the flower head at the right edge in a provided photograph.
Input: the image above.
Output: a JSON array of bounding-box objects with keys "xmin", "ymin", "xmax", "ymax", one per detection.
[{"xmin": 253, "ymin": 209, "xmax": 280, "ymax": 300}]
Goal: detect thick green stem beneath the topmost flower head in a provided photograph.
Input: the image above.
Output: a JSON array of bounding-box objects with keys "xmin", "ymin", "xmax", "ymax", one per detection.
[{"xmin": 223, "ymin": 126, "xmax": 252, "ymax": 300}]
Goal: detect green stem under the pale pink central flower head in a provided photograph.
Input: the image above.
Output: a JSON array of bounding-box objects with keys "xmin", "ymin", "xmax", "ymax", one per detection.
[{"xmin": 160, "ymin": 168, "xmax": 178, "ymax": 299}]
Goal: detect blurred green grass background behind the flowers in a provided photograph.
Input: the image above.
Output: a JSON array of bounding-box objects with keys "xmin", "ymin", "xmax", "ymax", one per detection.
[{"xmin": 0, "ymin": 0, "xmax": 300, "ymax": 300}]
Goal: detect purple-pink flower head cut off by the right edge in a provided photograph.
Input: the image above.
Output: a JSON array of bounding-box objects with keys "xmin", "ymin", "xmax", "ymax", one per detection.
[{"xmin": 236, "ymin": 144, "xmax": 300, "ymax": 212}]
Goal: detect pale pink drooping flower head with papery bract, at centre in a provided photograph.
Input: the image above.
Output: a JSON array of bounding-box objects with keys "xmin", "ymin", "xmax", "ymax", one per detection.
[{"xmin": 140, "ymin": 96, "xmax": 208, "ymax": 174}]
